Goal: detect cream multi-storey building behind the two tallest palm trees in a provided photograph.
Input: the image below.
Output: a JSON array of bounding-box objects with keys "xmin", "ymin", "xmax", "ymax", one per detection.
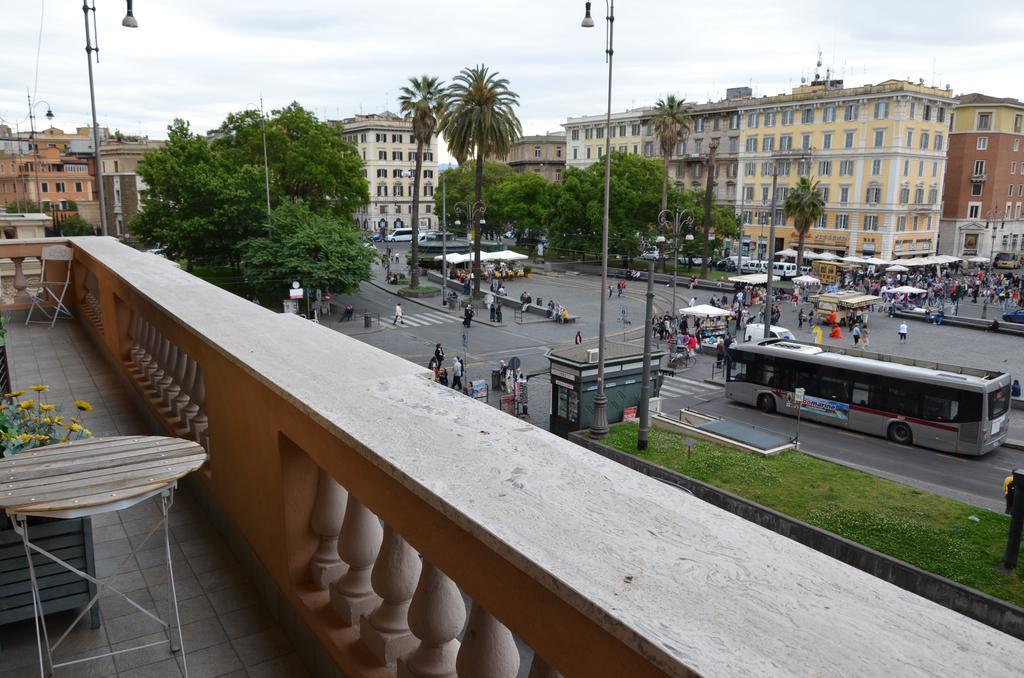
[{"xmin": 335, "ymin": 112, "xmax": 437, "ymax": 231}]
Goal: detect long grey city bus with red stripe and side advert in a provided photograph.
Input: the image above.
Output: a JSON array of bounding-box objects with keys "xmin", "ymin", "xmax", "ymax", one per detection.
[{"xmin": 725, "ymin": 339, "xmax": 1010, "ymax": 456}]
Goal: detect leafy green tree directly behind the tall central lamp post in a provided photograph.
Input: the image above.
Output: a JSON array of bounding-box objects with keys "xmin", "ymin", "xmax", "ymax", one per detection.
[{"xmin": 548, "ymin": 153, "xmax": 663, "ymax": 256}]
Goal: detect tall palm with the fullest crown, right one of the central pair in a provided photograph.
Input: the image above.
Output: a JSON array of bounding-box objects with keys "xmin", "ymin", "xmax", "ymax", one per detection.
[{"xmin": 440, "ymin": 65, "xmax": 522, "ymax": 294}]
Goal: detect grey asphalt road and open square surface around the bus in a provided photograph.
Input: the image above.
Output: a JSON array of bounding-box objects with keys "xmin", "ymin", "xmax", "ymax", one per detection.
[{"xmin": 330, "ymin": 242, "xmax": 1024, "ymax": 510}]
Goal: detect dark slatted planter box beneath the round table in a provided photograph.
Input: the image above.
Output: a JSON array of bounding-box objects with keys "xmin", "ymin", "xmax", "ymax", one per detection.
[{"xmin": 0, "ymin": 518, "xmax": 99, "ymax": 629}]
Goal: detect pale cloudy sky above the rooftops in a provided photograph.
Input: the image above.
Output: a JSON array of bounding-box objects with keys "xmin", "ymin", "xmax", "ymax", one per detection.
[{"xmin": 0, "ymin": 0, "xmax": 1024, "ymax": 160}]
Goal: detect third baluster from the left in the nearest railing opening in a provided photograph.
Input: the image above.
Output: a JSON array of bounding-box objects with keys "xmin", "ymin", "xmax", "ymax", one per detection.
[{"xmin": 359, "ymin": 525, "xmax": 421, "ymax": 666}]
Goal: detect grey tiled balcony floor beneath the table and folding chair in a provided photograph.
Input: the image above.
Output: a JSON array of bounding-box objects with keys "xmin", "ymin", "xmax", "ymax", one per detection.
[{"xmin": 0, "ymin": 314, "xmax": 307, "ymax": 678}]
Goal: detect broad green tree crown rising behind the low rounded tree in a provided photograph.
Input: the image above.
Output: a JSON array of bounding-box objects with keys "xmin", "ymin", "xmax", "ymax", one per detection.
[{"xmin": 211, "ymin": 101, "xmax": 370, "ymax": 216}]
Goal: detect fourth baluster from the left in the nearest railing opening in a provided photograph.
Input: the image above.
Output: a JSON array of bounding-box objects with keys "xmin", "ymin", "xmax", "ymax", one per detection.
[{"xmin": 398, "ymin": 560, "xmax": 466, "ymax": 678}]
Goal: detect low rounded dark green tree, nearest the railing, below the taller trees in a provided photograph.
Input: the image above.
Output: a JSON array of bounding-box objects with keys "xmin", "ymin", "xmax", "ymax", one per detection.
[{"xmin": 245, "ymin": 201, "xmax": 377, "ymax": 294}]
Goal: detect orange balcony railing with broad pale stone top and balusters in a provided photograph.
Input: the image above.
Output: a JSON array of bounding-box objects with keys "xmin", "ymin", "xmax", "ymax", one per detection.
[{"xmin": 0, "ymin": 238, "xmax": 1024, "ymax": 678}]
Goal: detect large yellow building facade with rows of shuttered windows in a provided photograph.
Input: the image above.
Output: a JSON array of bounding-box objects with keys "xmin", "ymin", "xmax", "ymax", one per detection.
[{"xmin": 736, "ymin": 80, "xmax": 955, "ymax": 258}]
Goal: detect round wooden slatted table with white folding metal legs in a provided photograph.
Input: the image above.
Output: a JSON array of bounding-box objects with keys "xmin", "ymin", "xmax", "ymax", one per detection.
[{"xmin": 0, "ymin": 435, "xmax": 207, "ymax": 677}]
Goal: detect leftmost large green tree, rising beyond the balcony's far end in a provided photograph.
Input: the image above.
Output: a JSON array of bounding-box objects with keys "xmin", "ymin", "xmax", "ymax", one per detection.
[{"xmin": 128, "ymin": 120, "xmax": 266, "ymax": 267}]
